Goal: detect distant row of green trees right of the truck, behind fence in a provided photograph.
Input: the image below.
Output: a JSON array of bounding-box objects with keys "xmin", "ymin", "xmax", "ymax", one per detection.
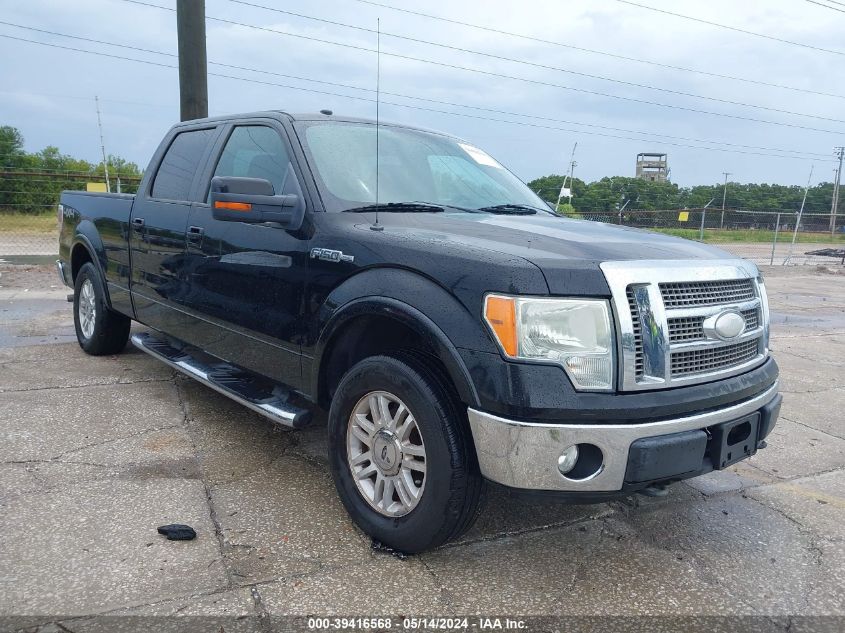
[{"xmin": 528, "ymin": 174, "xmax": 841, "ymax": 214}]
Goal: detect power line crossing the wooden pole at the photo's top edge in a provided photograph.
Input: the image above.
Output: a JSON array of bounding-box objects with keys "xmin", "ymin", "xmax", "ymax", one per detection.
[{"xmin": 112, "ymin": 0, "xmax": 841, "ymax": 134}]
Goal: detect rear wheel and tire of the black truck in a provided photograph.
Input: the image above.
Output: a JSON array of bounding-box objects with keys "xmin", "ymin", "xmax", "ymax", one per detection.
[{"xmin": 73, "ymin": 262, "xmax": 132, "ymax": 356}]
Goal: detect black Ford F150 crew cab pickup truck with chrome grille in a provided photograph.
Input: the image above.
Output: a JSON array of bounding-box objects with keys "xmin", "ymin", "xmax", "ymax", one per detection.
[{"xmin": 58, "ymin": 111, "xmax": 781, "ymax": 552}]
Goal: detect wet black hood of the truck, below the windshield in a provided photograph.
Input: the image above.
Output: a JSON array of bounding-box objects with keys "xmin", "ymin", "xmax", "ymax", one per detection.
[{"xmin": 370, "ymin": 213, "xmax": 734, "ymax": 294}]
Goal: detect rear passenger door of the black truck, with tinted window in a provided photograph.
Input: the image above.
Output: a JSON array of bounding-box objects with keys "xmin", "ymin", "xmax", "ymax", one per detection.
[{"xmin": 129, "ymin": 124, "xmax": 220, "ymax": 338}]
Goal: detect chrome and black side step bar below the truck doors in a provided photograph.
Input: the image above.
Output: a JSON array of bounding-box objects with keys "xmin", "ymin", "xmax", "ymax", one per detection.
[{"xmin": 131, "ymin": 332, "xmax": 311, "ymax": 429}]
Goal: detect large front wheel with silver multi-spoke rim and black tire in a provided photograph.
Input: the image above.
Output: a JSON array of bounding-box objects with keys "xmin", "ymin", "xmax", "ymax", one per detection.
[{"xmin": 328, "ymin": 353, "xmax": 483, "ymax": 553}]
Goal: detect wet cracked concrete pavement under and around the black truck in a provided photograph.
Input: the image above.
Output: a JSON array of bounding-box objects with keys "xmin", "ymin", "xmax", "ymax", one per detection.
[{"xmin": 0, "ymin": 265, "xmax": 845, "ymax": 631}]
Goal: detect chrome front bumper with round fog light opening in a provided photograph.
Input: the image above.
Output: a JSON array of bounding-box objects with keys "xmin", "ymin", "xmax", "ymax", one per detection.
[{"xmin": 468, "ymin": 382, "xmax": 781, "ymax": 494}]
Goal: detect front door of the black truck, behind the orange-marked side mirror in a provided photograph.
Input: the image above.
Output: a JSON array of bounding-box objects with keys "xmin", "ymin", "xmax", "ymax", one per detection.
[{"xmin": 180, "ymin": 120, "xmax": 310, "ymax": 388}]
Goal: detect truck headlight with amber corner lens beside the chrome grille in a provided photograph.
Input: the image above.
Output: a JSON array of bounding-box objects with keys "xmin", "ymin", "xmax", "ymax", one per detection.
[{"xmin": 484, "ymin": 294, "xmax": 613, "ymax": 391}]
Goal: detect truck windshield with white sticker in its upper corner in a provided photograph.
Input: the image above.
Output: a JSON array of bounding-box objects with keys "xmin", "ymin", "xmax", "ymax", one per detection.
[{"xmin": 299, "ymin": 121, "xmax": 548, "ymax": 211}]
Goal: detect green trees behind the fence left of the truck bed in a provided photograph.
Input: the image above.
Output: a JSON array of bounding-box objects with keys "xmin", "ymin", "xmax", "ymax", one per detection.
[{"xmin": 0, "ymin": 125, "xmax": 142, "ymax": 214}]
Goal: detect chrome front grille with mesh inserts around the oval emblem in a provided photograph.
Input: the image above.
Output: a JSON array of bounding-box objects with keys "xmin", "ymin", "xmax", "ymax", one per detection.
[{"xmin": 601, "ymin": 260, "xmax": 768, "ymax": 391}]
